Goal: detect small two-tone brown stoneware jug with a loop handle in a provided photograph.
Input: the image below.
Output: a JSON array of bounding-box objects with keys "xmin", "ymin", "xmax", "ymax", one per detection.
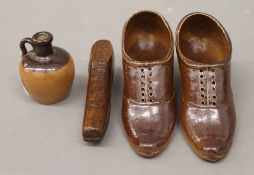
[{"xmin": 19, "ymin": 32, "xmax": 75, "ymax": 104}]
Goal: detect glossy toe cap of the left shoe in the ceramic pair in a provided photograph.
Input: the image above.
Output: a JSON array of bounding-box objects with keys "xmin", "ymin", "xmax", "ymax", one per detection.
[{"xmin": 123, "ymin": 100, "xmax": 175, "ymax": 157}]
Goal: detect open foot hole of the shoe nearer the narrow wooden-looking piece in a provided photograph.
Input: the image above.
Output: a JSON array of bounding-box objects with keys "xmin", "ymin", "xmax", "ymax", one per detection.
[{"xmin": 123, "ymin": 11, "xmax": 173, "ymax": 62}]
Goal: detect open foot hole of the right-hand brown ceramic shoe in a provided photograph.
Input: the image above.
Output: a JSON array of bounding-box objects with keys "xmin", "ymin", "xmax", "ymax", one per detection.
[{"xmin": 176, "ymin": 12, "xmax": 232, "ymax": 64}]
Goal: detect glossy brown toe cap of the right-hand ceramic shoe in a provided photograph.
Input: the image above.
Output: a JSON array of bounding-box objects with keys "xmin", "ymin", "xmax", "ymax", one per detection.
[{"xmin": 181, "ymin": 102, "xmax": 235, "ymax": 161}]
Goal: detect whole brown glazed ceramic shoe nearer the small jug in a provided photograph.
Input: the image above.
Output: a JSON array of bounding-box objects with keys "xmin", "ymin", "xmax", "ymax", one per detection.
[{"xmin": 122, "ymin": 11, "xmax": 176, "ymax": 157}]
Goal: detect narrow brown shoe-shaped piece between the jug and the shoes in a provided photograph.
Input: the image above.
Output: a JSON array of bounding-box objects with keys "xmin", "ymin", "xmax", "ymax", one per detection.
[{"xmin": 82, "ymin": 40, "xmax": 114, "ymax": 141}]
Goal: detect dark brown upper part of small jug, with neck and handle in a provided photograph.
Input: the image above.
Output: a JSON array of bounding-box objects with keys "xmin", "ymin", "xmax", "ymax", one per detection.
[{"xmin": 20, "ymin": 32, "xmax": 70, "ymax": 72}]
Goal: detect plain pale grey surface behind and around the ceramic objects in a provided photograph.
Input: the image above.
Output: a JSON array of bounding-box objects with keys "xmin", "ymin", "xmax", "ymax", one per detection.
[{"xmin": 0, "ymin": 0, "xmax": 254, "ymax": 175}]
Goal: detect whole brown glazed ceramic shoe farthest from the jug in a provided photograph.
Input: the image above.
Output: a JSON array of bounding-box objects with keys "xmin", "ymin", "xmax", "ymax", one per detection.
[{"xmin": 176, "ymin": 13, "xmax": 235, "ymax": 161}]
